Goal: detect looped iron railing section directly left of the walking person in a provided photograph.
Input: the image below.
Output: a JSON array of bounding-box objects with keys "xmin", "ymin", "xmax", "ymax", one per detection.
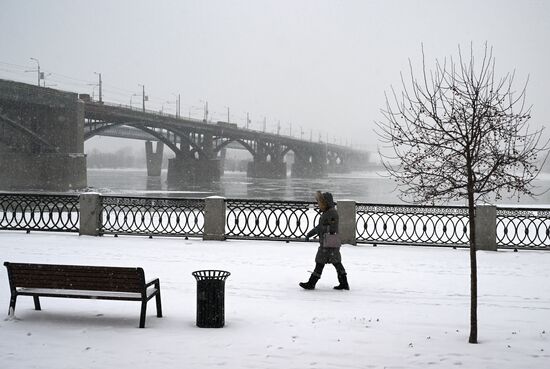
[{"xmin": 225, "ymin": 200, "xmax": 320, "ymax": 240}]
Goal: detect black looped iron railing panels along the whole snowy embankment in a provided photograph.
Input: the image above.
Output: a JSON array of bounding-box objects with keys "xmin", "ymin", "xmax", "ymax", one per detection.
[{"xmin": 0, "ymin": 193, "xmax": 550, "ymax": 250}]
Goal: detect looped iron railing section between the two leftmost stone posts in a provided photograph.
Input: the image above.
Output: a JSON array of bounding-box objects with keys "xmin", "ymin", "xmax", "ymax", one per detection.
[{"xmin": 101, "ymin": 196, "xmax": 204, "ymax": 236}]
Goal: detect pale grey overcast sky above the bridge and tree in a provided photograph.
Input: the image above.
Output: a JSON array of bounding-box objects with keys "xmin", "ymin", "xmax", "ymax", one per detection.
[{"xmin": 0, "ymin": 0, "xmax": 550, "ymax": 150}]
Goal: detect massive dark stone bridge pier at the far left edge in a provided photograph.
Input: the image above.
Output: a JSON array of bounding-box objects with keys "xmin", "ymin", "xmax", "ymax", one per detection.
[{"xmin": 0, "ymin": 80, "xmax": 87, "ymax": 191}]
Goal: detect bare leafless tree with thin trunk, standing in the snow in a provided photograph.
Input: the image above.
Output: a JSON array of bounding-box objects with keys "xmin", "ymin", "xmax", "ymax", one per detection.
[{"xmin": 377, "ymin": 44, "xmax": 548, "ymax": 343}]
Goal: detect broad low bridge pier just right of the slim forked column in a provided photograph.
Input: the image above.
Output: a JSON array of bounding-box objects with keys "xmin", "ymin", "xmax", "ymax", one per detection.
[{"xmin": 167, "ymin": 156, "xmax": 221, "ymax": 186}]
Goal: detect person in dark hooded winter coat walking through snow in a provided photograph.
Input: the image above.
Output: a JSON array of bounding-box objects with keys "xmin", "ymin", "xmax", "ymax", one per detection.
[{"xmin": 300, "ymin": 191, "xmax": 349, "ymax": 290}]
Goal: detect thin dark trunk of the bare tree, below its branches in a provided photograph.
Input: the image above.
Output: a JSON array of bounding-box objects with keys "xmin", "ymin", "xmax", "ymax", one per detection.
[{"xmin": 468, "ymin": 190, "xmax": 477, "ymax": 343}]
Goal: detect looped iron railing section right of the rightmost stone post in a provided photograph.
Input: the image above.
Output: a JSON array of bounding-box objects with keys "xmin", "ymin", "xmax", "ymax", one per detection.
[{"xmin": 496, "ymin": 207, "xmax": 550, "ymax": 249}]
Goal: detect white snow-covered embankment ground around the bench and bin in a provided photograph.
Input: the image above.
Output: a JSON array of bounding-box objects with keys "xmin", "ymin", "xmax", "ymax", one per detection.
[{"xmin": 0, "ymin": 232, "xmax": 550, "ymax": 369}]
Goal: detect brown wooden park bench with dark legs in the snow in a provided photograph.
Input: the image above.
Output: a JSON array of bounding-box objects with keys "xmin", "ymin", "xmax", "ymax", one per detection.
[{"xmin": 4, "ymin": 262, "xmax": 162, "ymax": 328}]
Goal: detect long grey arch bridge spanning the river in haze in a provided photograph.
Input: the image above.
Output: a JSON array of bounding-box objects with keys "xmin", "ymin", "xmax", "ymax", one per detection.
[{"xmin": 0, "ymin": 80, "xmax": 368, "ymax": 188}]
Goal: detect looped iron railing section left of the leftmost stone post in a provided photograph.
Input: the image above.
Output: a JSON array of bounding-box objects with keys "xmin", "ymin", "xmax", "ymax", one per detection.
[{"xmin": 0, "ymin": 194, "xmax": 80, "ymax": 232}]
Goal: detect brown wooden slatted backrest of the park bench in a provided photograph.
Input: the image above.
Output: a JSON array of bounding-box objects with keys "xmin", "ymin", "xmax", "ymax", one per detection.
[{"xmin": 4, "ymin": 262, "xmax": 145, "ymax": 293}]
